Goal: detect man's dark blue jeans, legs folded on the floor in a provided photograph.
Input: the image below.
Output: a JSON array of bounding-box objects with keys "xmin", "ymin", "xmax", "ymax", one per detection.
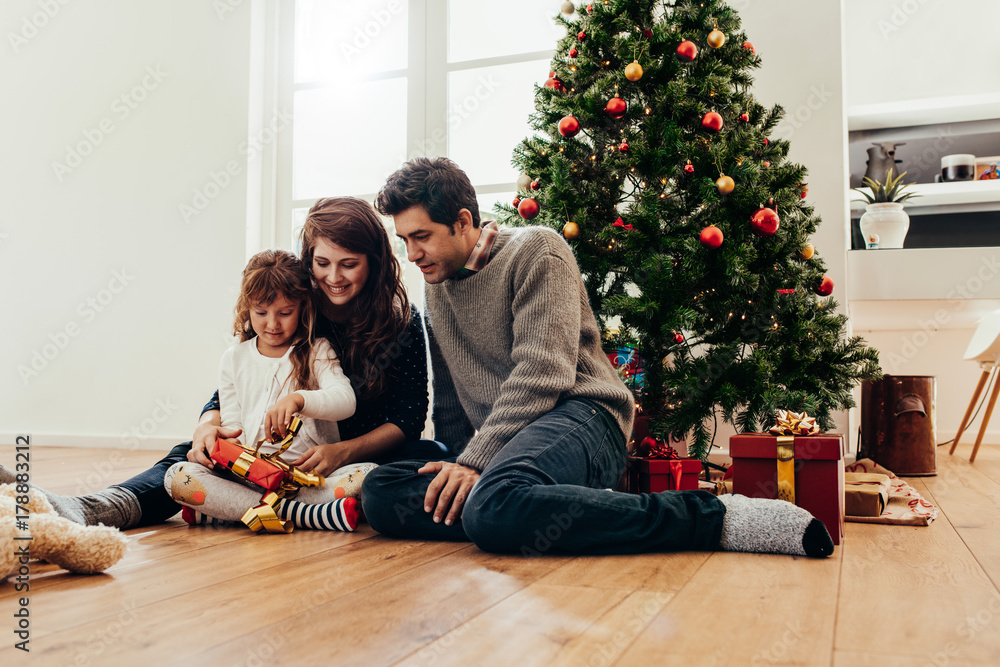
[{"xmin": 361, "ymin": 399, "xmax": 726, "ymax": 556}]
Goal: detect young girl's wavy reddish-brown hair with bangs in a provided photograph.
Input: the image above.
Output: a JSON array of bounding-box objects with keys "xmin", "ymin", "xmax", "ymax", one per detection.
[{"xmin": 233, "ymin": 250, "xmax": 317, "ymax": 390}]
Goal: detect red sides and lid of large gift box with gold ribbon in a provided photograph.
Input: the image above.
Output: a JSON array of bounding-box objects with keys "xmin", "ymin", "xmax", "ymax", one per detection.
[{"xmin": 729, "ymin": 433, "xmax": 844, "ymax": 544}]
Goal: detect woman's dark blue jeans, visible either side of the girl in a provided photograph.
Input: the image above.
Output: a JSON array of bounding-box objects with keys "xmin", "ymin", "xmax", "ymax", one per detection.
[{"xmin": 115, "ymin": 440, "xmax": 448, "ymax": 528}]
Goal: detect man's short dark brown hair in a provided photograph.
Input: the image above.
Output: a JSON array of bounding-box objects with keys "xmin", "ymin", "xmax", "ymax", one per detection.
[{"xmin": 375, "ymin": 157, "xmax": 479, "ymax": 234}]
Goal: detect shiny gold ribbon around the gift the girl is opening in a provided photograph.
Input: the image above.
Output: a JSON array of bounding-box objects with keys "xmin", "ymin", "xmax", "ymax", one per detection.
[{"xmin": 232, "ymin": 416, "xmax": 326, "ymax": 533}]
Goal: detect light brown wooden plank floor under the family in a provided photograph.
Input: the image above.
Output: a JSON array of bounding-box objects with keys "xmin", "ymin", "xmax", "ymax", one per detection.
[{"xmin": 0, "ymin": 446, "xmax": 1000, "ymax": 667}]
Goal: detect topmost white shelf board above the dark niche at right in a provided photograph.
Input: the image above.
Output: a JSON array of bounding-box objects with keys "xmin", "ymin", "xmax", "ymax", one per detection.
[{"xmin": 847, "ymin": 93, "xmax": 1000, "ymax": 132}]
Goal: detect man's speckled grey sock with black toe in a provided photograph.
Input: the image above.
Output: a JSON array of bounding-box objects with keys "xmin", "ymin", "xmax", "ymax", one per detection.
[{"xmin": 719, "ymin": 494, "xmax": 833, "ymax": 558}]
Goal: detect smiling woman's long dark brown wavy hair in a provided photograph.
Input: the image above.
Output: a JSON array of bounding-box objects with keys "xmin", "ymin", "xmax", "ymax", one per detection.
[{"xmin": 302, "ymin": 197, "xmax": 410, "ymax": 398}]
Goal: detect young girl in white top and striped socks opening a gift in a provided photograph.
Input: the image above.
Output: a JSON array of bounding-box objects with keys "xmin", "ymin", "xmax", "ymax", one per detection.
[{"xmin": 164, "ymin": 250, "xmax": 374, "ymax": 531}]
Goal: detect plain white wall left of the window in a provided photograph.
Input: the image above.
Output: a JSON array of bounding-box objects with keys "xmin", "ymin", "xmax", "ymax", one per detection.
[{"xmin": 0, "ymin": 0, "xmax": 250, "ymax": 449}]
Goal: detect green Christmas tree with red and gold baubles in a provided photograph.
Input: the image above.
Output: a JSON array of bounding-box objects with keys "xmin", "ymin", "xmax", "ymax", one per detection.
[{"xmin": 497, "ymin": 0, "xmax": 880, "ymax": 458}]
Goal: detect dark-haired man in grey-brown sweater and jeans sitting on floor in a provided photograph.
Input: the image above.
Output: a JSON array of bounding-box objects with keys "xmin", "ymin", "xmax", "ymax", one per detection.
[{"xmin": 362, "ymin": 158, "xmax": 833, "ymax": 557}]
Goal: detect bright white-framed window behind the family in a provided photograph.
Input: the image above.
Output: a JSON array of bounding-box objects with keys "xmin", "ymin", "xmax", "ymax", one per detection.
[{"xmin": 258, "ymin": 0, "xmax": 563, "ymax": 262}]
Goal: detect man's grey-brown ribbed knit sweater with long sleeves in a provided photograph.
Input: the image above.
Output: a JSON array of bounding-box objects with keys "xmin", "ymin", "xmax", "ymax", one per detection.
[{"xmin": 425, "ymin": 227, "xmax": 635, "ymax": 470}]
